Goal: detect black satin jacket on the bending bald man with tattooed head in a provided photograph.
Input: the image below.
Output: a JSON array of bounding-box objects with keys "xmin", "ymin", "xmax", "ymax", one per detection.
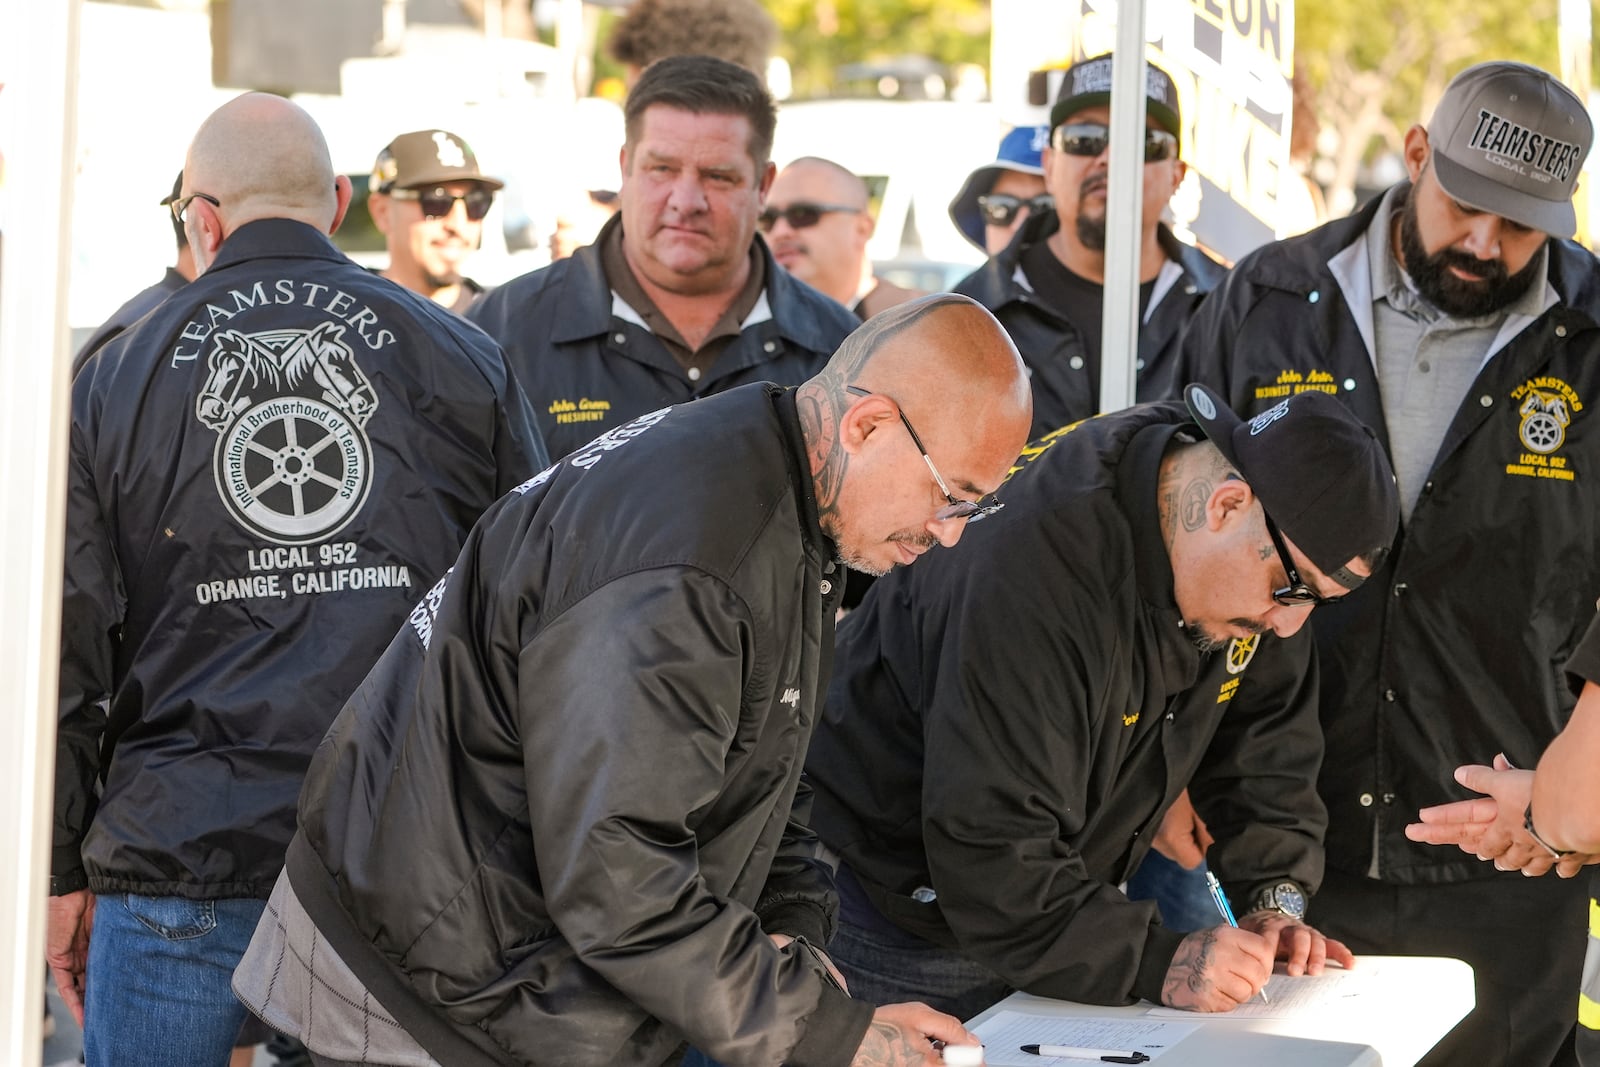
[{"xmin": 288, "ymin": 386, "xmax": 872, "ymax": 1067}]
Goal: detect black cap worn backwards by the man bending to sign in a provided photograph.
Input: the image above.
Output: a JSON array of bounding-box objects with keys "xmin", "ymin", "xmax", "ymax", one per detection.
[{"xmin": 1184, "ymin": 386, "xmax": 1400, "ymax": 589}]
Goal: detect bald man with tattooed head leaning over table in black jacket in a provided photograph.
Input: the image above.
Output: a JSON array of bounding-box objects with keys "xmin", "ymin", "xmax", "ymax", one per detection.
[{"xmin": 234, "ymin": 296, "xmax": 1032, "ymax": 1067}]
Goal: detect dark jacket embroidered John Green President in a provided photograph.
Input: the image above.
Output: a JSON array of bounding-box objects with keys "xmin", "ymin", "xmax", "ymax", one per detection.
[{"xmin": 467, "ymin": 218, "xmax": 861, "ymax": 458}]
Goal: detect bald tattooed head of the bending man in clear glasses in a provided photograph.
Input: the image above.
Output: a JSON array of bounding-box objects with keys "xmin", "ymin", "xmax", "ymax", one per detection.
[{"xmin": 797, "ymin": 293, "xmax": 1034, "ymax": 573}]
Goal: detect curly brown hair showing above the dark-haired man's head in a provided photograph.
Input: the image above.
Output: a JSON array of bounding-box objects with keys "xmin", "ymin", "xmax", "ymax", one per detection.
[{"xmin": 606, "ymin": 0, "xmax": 778, "ymax": 83}]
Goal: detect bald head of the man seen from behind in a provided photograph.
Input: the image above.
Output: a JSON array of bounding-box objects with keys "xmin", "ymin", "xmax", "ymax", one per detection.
[{"xmin": 184, "ymin": 93, "xmax": 347, "ymax": 237}]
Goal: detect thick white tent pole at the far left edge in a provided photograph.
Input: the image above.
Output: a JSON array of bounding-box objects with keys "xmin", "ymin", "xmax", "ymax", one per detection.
[{"xmin": 0, "ymin": 0, "xmax": 82, "ymax": 1064}]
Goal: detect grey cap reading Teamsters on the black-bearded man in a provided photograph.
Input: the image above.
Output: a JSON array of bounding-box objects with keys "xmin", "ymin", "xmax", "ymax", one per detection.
[{"xmin": 1427, "ymin": 62, "xmax": 1595, "ymax": 237}]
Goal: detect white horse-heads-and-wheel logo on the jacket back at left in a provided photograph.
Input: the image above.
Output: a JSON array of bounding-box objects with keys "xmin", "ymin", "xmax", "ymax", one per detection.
[{"xmin": 195, "ymin": 323, "xmax": 378, "ymax": 544}]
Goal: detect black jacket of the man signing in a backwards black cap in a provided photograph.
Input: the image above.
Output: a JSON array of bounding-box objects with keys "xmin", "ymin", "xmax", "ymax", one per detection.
[{"xmin": 806, "ymin": 403, "xmax": 1325, "ymax": 1005}]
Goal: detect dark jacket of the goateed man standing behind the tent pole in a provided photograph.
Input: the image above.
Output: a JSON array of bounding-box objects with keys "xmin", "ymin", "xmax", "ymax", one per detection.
[{"xmin": 955, "ymin": 211, "xmax": 1227, "ymax": 437}]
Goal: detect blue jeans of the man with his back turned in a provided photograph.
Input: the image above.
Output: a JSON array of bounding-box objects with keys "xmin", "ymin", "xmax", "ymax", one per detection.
[{"xmin": 83, "ymin": 893, "xmax": 267, "ymax": 1067}]
